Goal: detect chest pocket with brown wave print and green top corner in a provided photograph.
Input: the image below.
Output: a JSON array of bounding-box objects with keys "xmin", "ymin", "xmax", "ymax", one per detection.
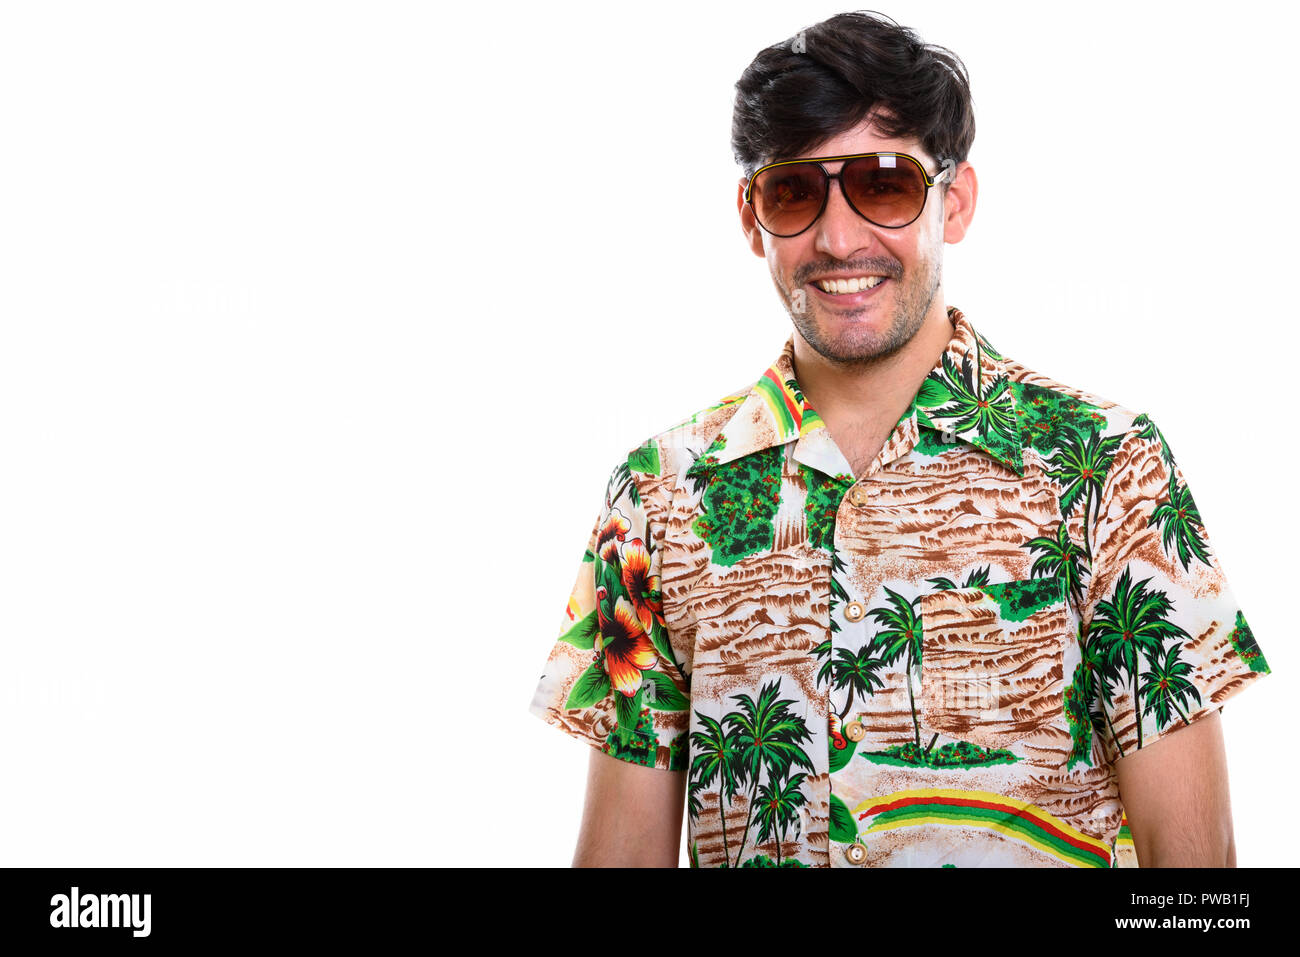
[{"xmin": 918, "ymin": 576, "xmax": 1074, "ymax": 748}]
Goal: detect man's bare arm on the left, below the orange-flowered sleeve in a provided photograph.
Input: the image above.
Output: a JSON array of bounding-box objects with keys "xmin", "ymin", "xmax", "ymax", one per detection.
[{"xmin": 573, "ymin": 750, "xmax": 686, "ymax": 867}]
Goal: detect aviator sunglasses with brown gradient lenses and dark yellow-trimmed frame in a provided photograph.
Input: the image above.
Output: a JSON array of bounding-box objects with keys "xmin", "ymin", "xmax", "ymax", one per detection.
[{"xmin": 745, "ymin": 152, "xmax": 957, "ymax": 239}]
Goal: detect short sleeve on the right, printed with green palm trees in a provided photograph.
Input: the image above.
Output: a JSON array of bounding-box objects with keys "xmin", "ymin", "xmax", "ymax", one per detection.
[{"xmin": 1082, "ymin": 415, "xmax": 1269, "ymax": 763}]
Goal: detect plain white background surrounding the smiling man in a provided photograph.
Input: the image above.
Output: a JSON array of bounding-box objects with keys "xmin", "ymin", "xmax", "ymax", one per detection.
[{"xmin": 0, "ymin": 0, "xmax": 1300, "ymax": 866}]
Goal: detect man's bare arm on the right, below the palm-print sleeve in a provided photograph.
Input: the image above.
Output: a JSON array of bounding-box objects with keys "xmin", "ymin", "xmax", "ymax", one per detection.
[{"xmin": 1115, "ymin": 710, "xmax": 1236, "ymax": 867}]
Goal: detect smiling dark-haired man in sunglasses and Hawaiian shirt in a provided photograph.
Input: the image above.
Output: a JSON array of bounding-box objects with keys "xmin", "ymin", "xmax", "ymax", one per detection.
[{"xmin": 532, "ymin": 14, "xmax": 1269, "ymax": 867}]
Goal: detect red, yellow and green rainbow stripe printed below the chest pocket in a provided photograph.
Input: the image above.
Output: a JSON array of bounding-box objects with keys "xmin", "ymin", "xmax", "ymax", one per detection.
[{"xmin": 853, "ymin": 788, "xmax": 1110, "ymax": 867}]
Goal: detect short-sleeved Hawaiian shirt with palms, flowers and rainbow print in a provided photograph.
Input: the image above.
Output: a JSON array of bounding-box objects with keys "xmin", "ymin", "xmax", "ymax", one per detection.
[{"xmin": 530, "ymin": 307, "xmax": 1269, "ymax": 867}]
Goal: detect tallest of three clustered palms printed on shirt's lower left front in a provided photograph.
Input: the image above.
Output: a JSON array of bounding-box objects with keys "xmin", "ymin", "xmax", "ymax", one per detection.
[{"xmin": 723, "ymin": 679, "xmax": 814, "ymax": 867}]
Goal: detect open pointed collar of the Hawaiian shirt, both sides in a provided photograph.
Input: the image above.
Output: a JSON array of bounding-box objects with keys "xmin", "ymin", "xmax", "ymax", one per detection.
[{"xmin": 686, "ymin": 306, "xmax": 1024, "ymax": 481}]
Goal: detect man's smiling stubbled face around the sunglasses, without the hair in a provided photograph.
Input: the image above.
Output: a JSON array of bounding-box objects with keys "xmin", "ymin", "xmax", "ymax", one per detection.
[{"xmin": 738, "ymin": 117, "xmax": 974, "ymax": 363}]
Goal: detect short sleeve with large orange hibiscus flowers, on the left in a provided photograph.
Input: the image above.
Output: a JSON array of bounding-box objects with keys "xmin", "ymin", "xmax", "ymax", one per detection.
[{"xmin": 529, "ymin": 456, "xmax": 689, "ymax": 771}]
